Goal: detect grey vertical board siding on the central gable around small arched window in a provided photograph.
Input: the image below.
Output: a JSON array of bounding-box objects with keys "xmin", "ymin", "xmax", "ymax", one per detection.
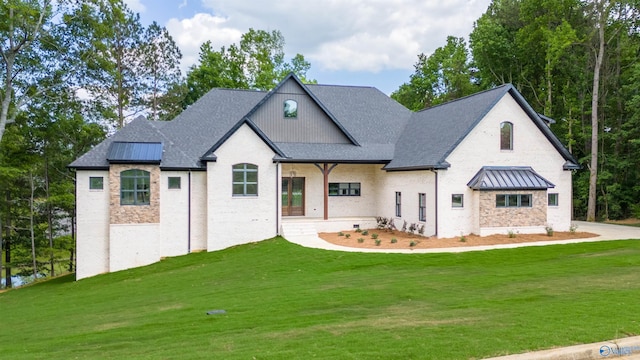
[{"xmin": 251, "ymin": 81, "xmax": 351, "ymax": 144}]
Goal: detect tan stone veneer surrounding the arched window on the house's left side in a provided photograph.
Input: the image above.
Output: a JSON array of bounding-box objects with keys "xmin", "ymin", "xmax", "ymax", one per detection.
[{"xmin": 109, "ymin": 164, "xmax": 160, "ymax": 224}]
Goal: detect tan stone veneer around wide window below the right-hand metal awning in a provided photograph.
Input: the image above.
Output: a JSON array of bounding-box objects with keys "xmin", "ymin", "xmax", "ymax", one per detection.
[{"xmin": 480, "ymin": 190, "xmax": 547, "ymax": 227}]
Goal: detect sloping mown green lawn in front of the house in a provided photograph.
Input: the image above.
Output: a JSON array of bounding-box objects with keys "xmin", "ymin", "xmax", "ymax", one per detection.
[{"xmin": 0, "ymin": 238, "xmax": 640, "ymax": 359}]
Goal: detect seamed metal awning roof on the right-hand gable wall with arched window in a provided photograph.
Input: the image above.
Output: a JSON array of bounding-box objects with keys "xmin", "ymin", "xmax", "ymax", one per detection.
[{"xmin": 467, "ymin": 166, "xmax": 555, "ymax": 190}]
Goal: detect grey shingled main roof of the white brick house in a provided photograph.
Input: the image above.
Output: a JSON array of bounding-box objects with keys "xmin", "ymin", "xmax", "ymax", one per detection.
[{"xmin": 69, "ymin": 74, "xmax": 578, "ymax": 170}]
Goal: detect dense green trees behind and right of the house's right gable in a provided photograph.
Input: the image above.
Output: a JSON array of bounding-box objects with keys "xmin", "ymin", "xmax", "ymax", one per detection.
[{"xmin": 392, "ymin": 0, "xmax": 640, "ymax": 221}]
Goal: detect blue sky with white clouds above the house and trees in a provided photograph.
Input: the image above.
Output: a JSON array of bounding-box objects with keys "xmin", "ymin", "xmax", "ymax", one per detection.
[{"xmin": 125, "ymin": 0, "xmax": 490, "ymax": 94}]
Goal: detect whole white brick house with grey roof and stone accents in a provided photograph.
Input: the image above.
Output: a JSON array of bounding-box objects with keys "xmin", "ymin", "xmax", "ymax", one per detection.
[{"xmin": 70, "ymin": 75, "xmax": 579, "ymax": 279}]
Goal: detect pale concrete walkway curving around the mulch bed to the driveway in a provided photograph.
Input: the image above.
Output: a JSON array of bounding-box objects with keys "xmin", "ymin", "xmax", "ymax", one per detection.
[{"xmin": 287, "ymin": 221, "xmax": 640, "ymax": 254}]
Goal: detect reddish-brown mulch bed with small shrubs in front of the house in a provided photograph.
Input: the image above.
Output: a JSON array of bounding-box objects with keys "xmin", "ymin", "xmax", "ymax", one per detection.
[{"xmin": 318, "ymin": 229, "xmax": 598, "ymax": 249}]
